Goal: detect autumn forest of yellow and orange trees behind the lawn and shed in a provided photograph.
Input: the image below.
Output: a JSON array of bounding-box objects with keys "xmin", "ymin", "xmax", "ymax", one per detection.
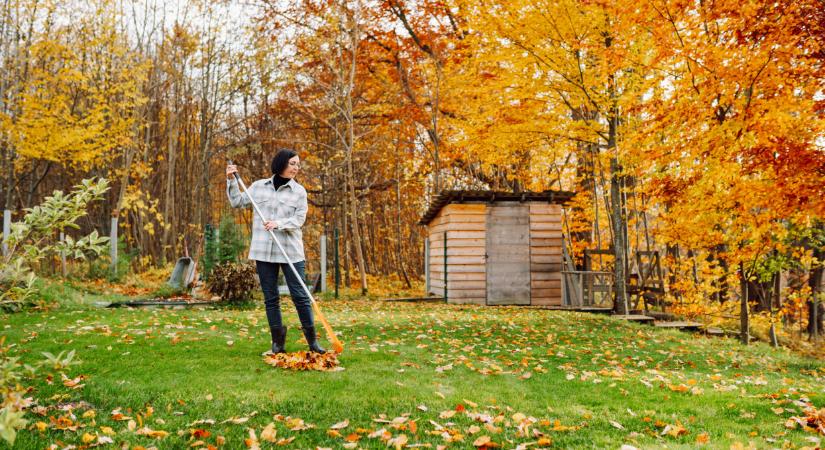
[{"xmin": 0, "ymin": 0, "xmax": 825, "ymax": 344}]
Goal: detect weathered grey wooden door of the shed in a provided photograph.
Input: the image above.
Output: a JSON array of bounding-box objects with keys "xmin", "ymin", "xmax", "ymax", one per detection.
[{"xmin": 487, "ymin": 203, "xmax": 530, "ymax": 305}]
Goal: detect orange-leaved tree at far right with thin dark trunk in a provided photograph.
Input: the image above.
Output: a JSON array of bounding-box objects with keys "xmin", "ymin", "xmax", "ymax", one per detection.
[{"xmin": 633, "ymin": 1, "xmax": 825, "ymax": 341}]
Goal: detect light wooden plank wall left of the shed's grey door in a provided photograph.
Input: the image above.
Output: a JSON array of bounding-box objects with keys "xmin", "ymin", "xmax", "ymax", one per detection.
[{"xmin": 429, "ymin": 203, "xmax": 487, "ymax": 305}]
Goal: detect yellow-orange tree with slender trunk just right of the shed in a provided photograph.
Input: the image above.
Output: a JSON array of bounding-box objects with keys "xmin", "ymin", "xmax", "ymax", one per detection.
[{"xmin": 455, "ymin": 1, "xmax": 648, "ymax": 314}]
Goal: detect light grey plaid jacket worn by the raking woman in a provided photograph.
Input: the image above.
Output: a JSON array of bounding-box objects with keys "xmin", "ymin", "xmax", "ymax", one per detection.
[{"xmin": 226, "ymin": 178, "xmax": 308, "ymax": 263}]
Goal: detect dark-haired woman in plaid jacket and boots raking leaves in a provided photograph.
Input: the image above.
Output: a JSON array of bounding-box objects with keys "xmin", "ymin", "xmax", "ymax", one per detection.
[{"xmin": 226, "ymin": 149, "xmax": 326, "ymax": 354}]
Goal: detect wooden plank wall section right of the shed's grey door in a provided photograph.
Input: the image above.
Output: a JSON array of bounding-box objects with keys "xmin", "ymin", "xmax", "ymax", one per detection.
[{"xmin": 530, "ymin": 203, "xmax": 563, "ymax": 306}]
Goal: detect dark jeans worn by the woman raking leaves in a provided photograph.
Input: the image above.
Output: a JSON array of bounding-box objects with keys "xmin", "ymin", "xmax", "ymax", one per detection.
[{"xmin": 255, "ymin": 261, "xmax": 314, "ymax": 329}]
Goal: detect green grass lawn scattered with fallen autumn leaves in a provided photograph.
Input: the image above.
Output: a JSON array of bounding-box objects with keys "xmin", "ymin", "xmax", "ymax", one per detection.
[{"xmin": 0, "ymin": 284, "xmax": 825, "ymax": 449}]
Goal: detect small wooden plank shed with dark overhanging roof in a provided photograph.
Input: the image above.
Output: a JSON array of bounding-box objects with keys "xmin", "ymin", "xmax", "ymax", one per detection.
[{"xmin": 419, "ymin": 191, "xmax": 574, "ymax": 306}]
